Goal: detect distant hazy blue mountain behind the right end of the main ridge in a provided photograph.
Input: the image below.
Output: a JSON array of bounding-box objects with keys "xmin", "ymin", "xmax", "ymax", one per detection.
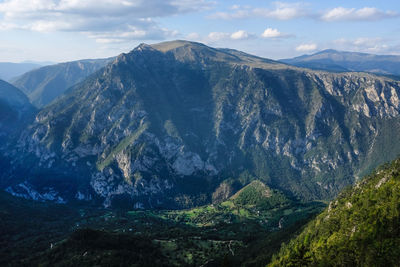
[{"xmin": 280, "ymin": 49, "xmax": 400, "ymax": 75}]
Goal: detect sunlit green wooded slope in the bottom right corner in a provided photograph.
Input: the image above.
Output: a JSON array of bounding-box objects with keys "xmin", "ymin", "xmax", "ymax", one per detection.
[{"xmin": 268, "ymin": 159, "xmax": 400, "ymax": 267}]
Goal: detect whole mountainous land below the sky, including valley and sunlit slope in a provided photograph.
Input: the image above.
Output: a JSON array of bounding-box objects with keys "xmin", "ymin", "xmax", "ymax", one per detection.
[{"xmin": 0, "ymin": 41, "xmax": 400, "ymax": 266}]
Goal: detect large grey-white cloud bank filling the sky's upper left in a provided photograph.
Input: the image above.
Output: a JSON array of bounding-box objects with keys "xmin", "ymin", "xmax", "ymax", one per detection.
[{"xmin": 0, "ymin": 0, "xmax": 212, "ymax": 43}]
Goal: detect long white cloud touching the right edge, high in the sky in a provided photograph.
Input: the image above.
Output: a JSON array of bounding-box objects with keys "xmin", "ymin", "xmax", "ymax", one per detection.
[{"xmin": 321, "ymin": 7, "xmax": 399, "ymax": 21}]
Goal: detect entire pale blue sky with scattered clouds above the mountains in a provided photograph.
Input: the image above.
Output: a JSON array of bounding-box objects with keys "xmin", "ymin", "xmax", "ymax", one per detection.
[{"xmin": 0, "ymin": 0, "xmax": 400, "ymax": 62}]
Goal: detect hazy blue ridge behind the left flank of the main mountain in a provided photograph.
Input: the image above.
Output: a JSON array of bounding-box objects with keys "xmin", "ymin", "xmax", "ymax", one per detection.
[{"xmin": 12, "ymin": 58, "xmax": 113, "ymax": 107}]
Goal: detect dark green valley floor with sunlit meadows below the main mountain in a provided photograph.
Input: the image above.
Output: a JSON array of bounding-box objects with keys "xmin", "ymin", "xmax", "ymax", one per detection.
[{"xmin": 0, "ymin": 189, "xmax": 324, "ymax": 266}]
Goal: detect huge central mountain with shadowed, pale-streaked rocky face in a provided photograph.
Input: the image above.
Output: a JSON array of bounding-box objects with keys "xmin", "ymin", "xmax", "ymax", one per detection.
[{"xmin": 3, "ymin": 41, "xmax": 400, "ymax": 208}]
